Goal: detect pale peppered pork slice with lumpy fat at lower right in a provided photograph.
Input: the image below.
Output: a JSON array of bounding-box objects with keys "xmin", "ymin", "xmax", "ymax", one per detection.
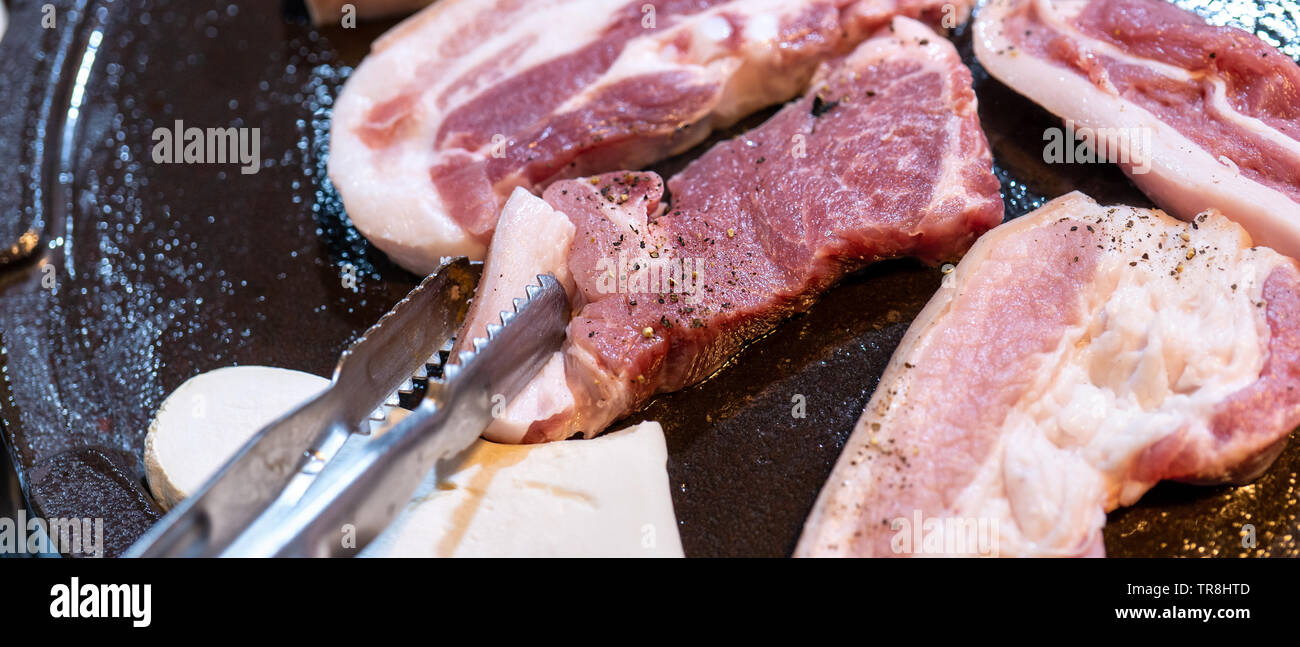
[{"xmin": 796, "ymin": 192, "xmax": 1300, "ymax": 556}]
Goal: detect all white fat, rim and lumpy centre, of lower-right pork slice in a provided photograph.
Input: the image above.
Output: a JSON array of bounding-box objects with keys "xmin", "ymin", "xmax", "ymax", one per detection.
[{"xmin": 797, "ymin": 192, "xmax": 1291, "ymax": 556}]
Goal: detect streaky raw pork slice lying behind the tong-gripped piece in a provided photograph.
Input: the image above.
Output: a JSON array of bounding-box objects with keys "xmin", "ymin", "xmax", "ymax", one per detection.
[{"xmin": 329, "ymin": 0, "xmax": 972, "ymax": 273}]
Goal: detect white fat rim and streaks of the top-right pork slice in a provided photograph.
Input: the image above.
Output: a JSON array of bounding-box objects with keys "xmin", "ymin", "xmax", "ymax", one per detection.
[{"xmin": 974, "ymin": 0, "xmax": 1300, "ymax": 256}]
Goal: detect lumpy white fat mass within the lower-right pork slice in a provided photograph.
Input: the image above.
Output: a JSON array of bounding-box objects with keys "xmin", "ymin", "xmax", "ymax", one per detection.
[{"xmin": 953, "ymin": 204, "xmax": 1277, "ymax": 556}]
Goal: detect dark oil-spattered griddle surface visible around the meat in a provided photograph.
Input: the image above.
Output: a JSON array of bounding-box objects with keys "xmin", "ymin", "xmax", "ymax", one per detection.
[{"xmin": 0, "ymin": 0, "xmax": 1300, "ymax": 556}]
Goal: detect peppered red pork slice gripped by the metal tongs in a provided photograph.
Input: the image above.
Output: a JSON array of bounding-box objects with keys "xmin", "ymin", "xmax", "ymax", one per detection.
[{"xmin": 465, "ymin": 18, "xmax": 1002, "ymax": 442}]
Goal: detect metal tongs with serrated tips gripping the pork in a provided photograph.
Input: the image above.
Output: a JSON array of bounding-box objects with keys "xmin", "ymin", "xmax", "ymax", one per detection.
[{"xmin": 126, "ymin": 257, "xmax": 568, "ymax": 557}]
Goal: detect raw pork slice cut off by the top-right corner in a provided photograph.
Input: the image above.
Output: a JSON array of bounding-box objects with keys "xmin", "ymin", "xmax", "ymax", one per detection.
[{"xmin": 975, "ymin": 0, "xmax": 1300, "ymax": 256}]
